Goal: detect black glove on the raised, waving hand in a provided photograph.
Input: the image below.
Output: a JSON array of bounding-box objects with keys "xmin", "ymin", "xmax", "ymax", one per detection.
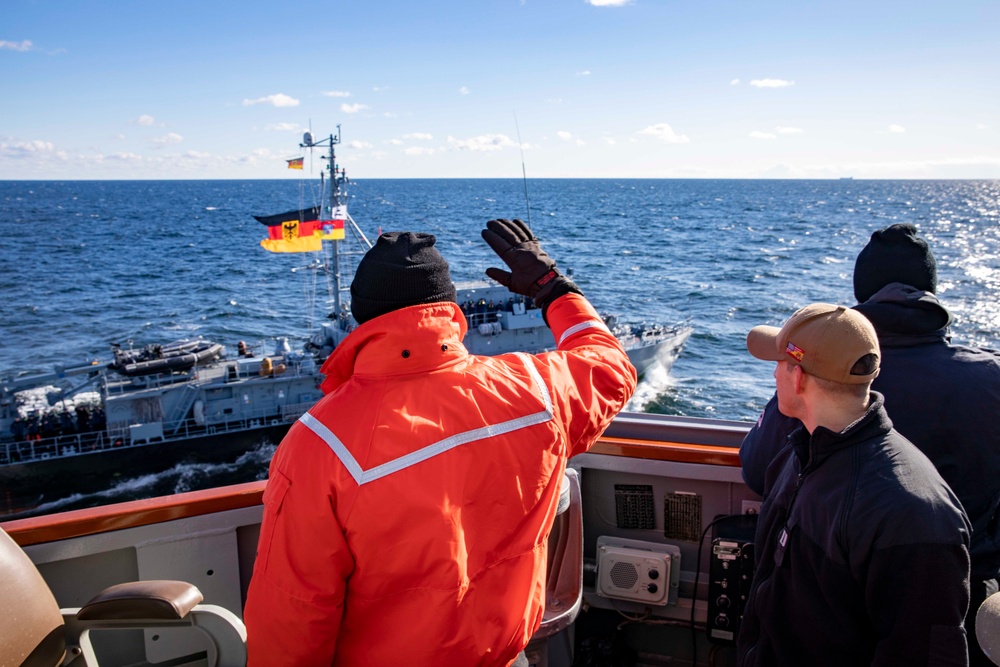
[{"xmin": 483, "ymin": 219, "xmax": 583, "ymax": 316}]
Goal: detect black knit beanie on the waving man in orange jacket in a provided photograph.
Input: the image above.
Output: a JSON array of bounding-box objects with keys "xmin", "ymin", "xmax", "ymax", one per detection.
[{"xmin": 351, "ymin": 232, "xmax": 458, "ymax": 324}]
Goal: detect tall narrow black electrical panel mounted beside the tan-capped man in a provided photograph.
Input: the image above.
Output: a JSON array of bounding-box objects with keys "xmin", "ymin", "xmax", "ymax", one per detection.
[{"xmin": 706, "ymin": 514, "xmax": 757, "ymax": 644}]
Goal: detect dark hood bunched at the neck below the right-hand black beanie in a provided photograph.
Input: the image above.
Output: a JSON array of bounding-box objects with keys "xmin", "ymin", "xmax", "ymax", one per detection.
[{"xmin": 854, "ymin": 283, "xmax": 952, "ymax": 346}]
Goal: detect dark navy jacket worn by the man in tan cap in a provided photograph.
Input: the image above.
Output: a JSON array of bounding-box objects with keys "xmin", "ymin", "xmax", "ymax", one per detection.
[{"xmin": 737, "ymin": 393, "xmax": 969, "ymax": 667}]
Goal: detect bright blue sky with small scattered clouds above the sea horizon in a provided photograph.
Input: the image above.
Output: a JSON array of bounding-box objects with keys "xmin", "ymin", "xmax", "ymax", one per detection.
[{"xmin": 0, "ymin": 0, "xmax": 1000, "ymax": 179}]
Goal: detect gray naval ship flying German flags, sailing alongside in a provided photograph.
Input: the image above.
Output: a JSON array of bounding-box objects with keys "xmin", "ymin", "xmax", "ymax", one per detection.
[{"xmin": 0, "ymin": 126, "xmax": 692, "ymax": 517}]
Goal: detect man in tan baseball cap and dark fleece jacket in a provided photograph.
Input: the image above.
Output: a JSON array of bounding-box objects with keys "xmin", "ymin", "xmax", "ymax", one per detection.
[{"xmin": 737, "ymin": 303, "xmax": 970, "ymax": 667}]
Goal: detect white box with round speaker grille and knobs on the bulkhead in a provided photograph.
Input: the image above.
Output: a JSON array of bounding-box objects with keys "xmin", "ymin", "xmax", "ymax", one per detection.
[{"xmin": 597, "ymin": 536, "xmax": 681, "ymax": 606}]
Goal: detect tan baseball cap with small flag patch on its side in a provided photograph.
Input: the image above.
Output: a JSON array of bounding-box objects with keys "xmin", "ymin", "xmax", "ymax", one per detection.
[{"xmin": 747, "ymin": 303, "xmax": 882, "ymax": 384}]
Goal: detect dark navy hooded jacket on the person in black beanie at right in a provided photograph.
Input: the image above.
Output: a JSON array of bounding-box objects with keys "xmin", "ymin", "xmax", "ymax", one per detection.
[{"xmin": 740, "ymin": 283, "xmax": 1000, "ymax": 581}]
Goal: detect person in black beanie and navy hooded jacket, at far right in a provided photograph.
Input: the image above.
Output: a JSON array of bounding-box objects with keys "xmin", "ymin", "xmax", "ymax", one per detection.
[{"xmin": 740, "ymin": 224, "xmax": 1000, "ymax": 667}]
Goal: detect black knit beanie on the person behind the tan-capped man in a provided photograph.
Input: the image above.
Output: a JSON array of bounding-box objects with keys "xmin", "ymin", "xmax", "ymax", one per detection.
[{"xmin": 854, "ymin": 224, "xmax": 937, "ymax": 303}]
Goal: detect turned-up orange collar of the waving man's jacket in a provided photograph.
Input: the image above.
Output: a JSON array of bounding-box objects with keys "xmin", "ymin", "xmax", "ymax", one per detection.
[{"xmin": 320, "ymin": 302, "xmax": 469, "ymax": 394}]
